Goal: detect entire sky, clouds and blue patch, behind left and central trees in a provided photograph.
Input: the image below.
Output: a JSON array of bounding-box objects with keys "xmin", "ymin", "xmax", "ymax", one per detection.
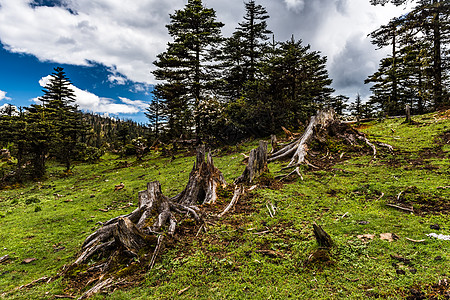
[{"xmin": 0, "ymin": 0, "xmax": 412, "ymax": 122}]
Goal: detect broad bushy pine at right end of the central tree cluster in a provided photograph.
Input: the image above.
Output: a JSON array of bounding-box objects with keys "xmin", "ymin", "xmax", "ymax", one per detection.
[{"xmin": 228, "ymin": 38, "xmax": 334, "ymax": 136}]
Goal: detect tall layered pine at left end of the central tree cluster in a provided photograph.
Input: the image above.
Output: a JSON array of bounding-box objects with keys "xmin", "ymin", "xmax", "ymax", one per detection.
[{"xmin": 153, "ymin": 0, "xmax": 223, "ymax": 141}]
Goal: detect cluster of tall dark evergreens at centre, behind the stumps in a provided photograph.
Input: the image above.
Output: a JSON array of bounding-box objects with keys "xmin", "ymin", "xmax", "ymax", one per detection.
[{"xmin": 147, "ymin": 0, "xmax": 345, "ymax": 142}]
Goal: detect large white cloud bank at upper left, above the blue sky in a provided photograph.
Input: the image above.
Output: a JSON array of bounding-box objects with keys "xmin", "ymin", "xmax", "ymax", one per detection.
[{"xmin": 0, "ymin": 0, "xmax": 184, "ymax": 83}]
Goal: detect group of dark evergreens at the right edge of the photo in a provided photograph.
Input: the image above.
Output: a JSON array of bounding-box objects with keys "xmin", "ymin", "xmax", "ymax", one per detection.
[{"xmin": 365, "ymin": 0, "xmax": 450, "ymax": 115}]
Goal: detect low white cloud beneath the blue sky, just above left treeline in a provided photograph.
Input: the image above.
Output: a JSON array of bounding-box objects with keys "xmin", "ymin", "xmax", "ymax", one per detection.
[{"xmin": 37, "ymin": 75, "xmax": 148, "ymax": 114}]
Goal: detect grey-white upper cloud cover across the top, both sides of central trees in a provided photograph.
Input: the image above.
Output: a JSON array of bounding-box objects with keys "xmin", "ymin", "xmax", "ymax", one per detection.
[{"xmin": 0, "ymin": 0, "xmax": 414, "ymax": 98}]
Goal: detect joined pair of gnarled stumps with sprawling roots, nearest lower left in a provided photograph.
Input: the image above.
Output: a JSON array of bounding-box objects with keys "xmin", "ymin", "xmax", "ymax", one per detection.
[{"xmin": 66, "ymin": 146, "xmax": 226, "ymax": 297}]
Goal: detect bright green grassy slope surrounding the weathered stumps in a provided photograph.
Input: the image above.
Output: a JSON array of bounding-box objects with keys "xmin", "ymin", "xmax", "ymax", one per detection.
[{"xmin": 0, "ymin": 114, "xmax": 450, "ymax": 299}]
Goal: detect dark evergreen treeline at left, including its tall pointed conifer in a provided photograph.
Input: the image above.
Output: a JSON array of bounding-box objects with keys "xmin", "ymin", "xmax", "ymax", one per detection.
[{"xmin": 0, "ymin": 67, "xmax": 148, "ymax": 180}]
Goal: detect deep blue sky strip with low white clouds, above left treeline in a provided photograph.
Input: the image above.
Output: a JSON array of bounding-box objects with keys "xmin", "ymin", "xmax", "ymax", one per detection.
[{"xmin": 0, "ymin": 41, "xmax": 152, "ymax": 123}]
